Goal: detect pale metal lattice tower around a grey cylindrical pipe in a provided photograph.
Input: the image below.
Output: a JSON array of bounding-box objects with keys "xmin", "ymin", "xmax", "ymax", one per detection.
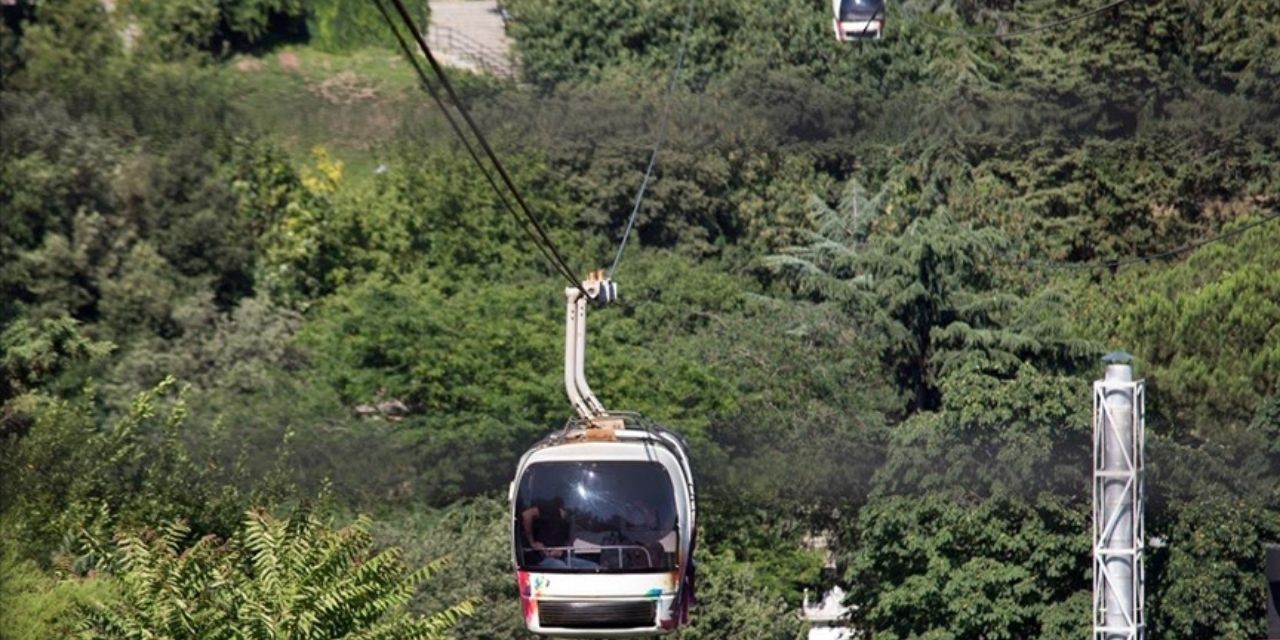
[{"xmin": 1093, "ymin": 355, "xmax": 1147, "ymax": 640}]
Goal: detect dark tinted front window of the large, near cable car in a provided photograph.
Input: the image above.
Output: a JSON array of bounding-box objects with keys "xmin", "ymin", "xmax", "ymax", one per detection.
[{"xmin": 515, "ymin": 462, "xmax": 678, "ymax": 572}]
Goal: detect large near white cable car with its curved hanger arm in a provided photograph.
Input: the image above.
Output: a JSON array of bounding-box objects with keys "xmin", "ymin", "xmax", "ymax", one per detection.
[{"xmin": 508, "ymin": 273, "xmax": 695, "ymax": 637}]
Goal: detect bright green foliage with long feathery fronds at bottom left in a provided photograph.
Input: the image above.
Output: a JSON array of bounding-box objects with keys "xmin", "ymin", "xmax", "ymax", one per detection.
[{"xmin": 82, "ymin": 508, "xmax": 474, "ymax": 640}]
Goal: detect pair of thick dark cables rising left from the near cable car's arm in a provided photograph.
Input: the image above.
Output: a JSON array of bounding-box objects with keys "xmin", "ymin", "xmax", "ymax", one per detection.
[{"xmin": 376, "ymin": 0, "xmax": 589, "ymax": 297}]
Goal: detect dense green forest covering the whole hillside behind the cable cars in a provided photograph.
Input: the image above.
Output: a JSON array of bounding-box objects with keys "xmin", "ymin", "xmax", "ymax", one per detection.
[{"xmin": 0, "ymin": 0, "xmax": 1280, "ymax": 640}]
